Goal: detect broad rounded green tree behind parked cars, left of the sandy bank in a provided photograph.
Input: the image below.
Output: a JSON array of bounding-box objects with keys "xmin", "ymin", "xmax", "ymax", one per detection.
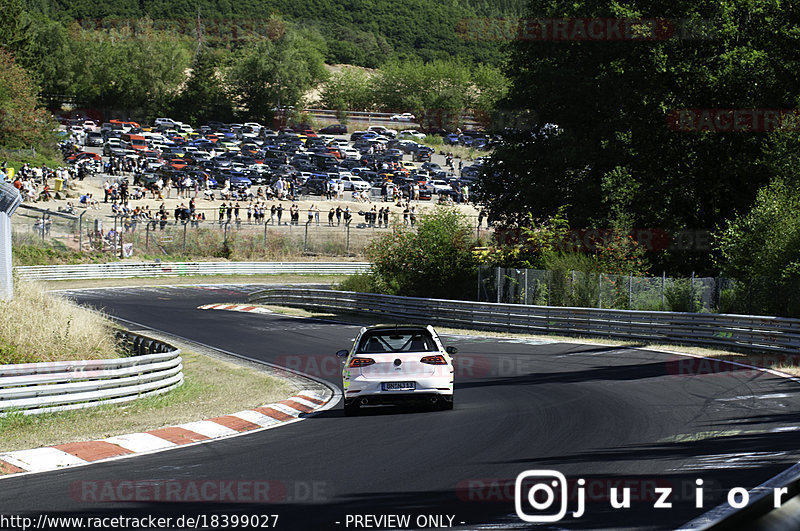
[{"xmin": 226, "ymin": 22, "xmax": 327, "ymax": 122}]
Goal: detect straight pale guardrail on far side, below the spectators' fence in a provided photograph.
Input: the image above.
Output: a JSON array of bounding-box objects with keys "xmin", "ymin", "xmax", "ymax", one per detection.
[{"xmin": 14, "ymin": 262, "xmax": 370, "ymax": 280}]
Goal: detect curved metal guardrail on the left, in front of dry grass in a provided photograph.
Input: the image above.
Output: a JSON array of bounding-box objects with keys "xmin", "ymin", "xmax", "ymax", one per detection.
[{"xmin": 0, "ymin": 332, "xmax": 183, "ymax": 415}]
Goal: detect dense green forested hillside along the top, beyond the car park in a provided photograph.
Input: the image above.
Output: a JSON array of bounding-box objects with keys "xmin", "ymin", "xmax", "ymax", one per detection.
[{"xmin": 21, "ymin": 0, "xmax": 524, "ymax": 68}]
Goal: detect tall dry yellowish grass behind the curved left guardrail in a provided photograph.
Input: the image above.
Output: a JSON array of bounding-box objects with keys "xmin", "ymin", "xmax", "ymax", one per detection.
[{"xmin": 0, "ymin": 282, "xmax": 119, "ymax": 364}]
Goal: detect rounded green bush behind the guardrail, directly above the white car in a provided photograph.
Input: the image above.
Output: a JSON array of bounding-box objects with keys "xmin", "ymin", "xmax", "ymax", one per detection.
[{"xmin": 366, "ymin": 207, "xmax": 476, "ymax": 299}]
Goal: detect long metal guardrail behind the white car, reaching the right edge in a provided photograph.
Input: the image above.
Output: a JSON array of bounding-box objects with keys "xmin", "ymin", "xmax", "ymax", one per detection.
[{"xmin": 250, "ymin": 288, "xmax": 800, "ymax": 354}]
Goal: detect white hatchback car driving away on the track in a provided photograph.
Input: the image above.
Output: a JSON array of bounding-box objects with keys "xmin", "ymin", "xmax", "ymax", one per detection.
[{"xmin": 336, "ymin": 325, "xmax": 456, "ymax": 416}]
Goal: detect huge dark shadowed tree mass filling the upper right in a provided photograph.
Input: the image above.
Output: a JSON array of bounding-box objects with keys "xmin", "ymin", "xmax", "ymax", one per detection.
[{"xmin": 479, "ymin": 0, "xmax": 800, "ymax": 272}]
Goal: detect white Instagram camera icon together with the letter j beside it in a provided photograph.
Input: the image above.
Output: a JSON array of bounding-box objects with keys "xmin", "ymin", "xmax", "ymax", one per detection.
[{"xmin": 514, "ymin": 470, "xmax": 583, "ymax": 522}]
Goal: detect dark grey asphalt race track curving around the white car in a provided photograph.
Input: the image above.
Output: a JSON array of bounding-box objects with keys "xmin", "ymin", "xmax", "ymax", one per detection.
[{"xmin": 0, "ymin": 286, "xmax": 800, "ymax": 530}]
